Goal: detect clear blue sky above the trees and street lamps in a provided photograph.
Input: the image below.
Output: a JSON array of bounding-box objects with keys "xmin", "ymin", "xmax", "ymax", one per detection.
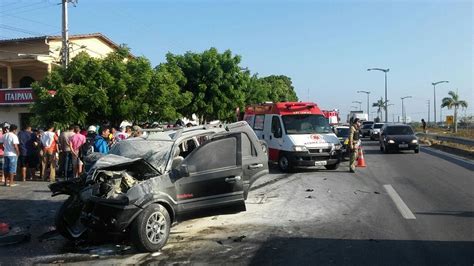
[{"xmin": 0, "ymin": 0, "xmax": 474, "ymax": 120}]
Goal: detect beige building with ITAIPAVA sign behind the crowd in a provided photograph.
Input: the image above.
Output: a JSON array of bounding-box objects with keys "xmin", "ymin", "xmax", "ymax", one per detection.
[{"xmin": 0, "ymin": 33, "xmax": 119, "ymax": 128}]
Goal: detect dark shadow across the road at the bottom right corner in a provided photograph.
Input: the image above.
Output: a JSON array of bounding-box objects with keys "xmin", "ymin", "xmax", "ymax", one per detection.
[{"xmin": 250, "ymin": 238, "xmax": 474, "ymax": 265}]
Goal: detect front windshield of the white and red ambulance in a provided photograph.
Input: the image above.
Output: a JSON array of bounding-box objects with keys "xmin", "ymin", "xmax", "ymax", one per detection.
[{"xmin": 282, "ymin": 114, "xmax": 332, "ymax": 135}]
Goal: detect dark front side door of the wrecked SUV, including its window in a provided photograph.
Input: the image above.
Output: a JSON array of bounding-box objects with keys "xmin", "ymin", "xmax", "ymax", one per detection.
[{"xmin": 175, "ymin": 133, "xmax": 244, "ymax": 211}]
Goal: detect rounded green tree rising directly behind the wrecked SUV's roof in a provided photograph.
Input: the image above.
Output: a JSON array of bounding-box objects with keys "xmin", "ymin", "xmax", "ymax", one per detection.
[{"xmin": 167, "ymin": 48, "xmax": 249, "ymax": 121}]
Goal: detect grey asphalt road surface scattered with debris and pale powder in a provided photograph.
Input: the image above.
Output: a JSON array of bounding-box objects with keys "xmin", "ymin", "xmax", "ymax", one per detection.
[{"xmin": 0, "ymin": 141, "xmax": 474, "ymax": 265}]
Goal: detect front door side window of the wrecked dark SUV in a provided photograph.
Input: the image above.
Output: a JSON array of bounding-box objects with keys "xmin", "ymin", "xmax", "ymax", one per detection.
[{"xmin": 183, "ymin": 136, "xmax": 238, "ymax": 172}]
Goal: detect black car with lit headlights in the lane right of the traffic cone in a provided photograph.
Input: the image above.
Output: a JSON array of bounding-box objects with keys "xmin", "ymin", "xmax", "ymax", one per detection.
[{"xmin": 380, "ymin": 124, "xmax": 420, "ymax": 153}]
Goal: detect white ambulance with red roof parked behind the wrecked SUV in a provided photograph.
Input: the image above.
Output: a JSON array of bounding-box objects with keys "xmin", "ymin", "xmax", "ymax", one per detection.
[{"xmin": 244, "ymin": 102, "xmax": 342, "ymax": 172}]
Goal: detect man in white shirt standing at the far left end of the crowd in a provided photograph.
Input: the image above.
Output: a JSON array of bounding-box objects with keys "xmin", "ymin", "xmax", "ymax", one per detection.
[{"xmin": 2, "ymin": 125, "xmax": 20, "ymax": 187}]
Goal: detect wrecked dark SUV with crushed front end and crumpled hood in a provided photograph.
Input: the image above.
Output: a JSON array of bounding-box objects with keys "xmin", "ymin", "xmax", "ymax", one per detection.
[{"xmin": 50, "ymin": 122, "xmax": 268, "ymax": 251}]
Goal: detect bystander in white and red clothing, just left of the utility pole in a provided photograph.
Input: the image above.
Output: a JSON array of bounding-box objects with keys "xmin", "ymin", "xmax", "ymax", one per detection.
[{"xmin": 41, "ymin": 125, "xmax": 58, "ymax": 182}]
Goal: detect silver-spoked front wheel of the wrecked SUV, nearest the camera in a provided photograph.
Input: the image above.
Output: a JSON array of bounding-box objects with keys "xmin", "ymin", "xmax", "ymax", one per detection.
[{"xmin": 130, "ymin": 204, "xmax": 171, "ymax": 252}]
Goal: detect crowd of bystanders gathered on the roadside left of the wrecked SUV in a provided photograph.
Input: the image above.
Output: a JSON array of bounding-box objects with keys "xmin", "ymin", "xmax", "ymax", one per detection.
[{"xmin": 0, "ymin": 123, "xmax": 143, "ymax": 186}]
